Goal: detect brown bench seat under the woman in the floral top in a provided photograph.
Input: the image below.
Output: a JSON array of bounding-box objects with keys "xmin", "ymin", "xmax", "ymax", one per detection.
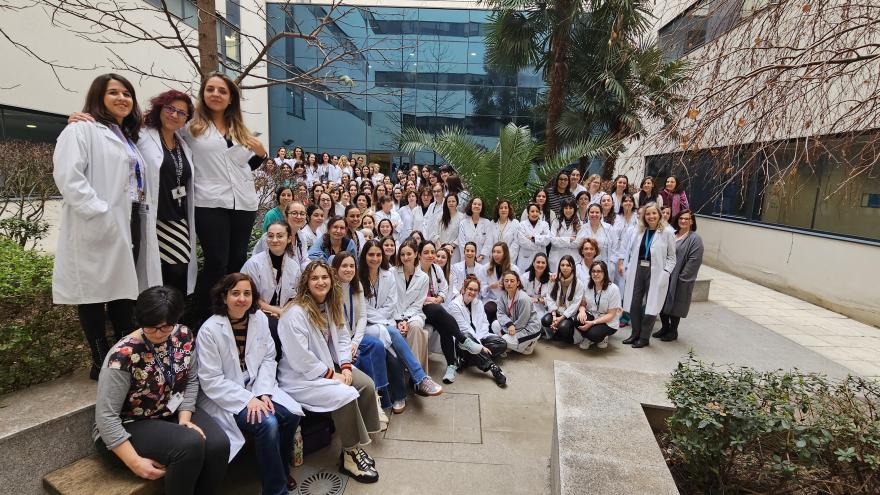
[{"xmin": 43, "ymin": 454, "xmax": 164, "ymax": 495}]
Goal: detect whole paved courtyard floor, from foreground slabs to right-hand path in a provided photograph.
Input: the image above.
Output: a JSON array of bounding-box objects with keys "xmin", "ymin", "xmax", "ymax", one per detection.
[{"xmin": 220, "ymin": 266, "xmax": 880, "ymax": 495}]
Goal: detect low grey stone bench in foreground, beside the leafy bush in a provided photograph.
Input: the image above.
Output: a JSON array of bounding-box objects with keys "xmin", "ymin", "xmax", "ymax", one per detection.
[{"xmin": 550, "ymin": 361, "xmax": 678, "ymax": 495}]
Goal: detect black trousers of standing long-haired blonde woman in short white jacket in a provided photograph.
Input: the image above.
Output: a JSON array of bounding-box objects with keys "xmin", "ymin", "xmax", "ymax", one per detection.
[{"xmin": 195, "ymin": 207, "xmax": 257, "ymax": 317}]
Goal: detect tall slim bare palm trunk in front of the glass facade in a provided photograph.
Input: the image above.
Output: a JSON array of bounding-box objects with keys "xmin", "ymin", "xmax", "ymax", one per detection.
[{"xmin": 544, "ymin": 0, "xmax": 576, "ymax": 157}]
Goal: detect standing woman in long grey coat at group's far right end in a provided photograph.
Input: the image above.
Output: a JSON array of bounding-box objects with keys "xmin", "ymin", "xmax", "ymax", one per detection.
[{"xmin": 653, "ymin": 209, "xmax": 703, "ymax": 342}]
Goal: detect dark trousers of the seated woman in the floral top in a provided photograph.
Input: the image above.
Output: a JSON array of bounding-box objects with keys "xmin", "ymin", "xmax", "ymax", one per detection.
[{"xmin": 95, "ymin": 410, "xmax": 229, "ymax": 495}]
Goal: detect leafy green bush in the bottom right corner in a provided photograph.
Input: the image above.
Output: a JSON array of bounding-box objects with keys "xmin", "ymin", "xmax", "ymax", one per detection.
[{"xmin": 661, "ymin": 355, "xmax": 880, "ymax": 494}]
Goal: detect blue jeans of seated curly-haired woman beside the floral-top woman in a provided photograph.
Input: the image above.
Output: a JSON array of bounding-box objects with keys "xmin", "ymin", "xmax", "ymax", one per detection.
[{"xmin": 235, "ymin": 402, "xmax": 301, "ymax": 495}]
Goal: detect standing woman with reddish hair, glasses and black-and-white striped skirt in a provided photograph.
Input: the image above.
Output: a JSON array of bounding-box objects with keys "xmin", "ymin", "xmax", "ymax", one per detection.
[{"xmin": 138, "ymin": 90, "xmax": 198, "ymax": 294}]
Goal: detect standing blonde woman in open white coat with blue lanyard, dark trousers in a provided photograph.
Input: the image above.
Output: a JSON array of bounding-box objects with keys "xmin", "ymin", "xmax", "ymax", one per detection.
[{"xmin": 623, "ymin": 204, "xmax": 675, "ymax": 349}]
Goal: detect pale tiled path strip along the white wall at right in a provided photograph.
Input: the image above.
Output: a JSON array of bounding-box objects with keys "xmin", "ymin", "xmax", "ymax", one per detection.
[{"xmin": 700, "ymin": 265, "xmax": 880, "ymax": 378}]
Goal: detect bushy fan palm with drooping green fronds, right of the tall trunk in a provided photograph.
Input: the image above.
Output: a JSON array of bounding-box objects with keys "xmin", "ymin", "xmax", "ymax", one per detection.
[{"xmin": 556, "ymin": 0, "xmax": 689, "ymax": 179}]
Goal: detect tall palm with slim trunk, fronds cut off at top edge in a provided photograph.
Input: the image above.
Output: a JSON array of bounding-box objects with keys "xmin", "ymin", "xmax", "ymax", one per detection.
[{"xmin": 483, "ymin": 0, "xmax": 585, "ymax": 156}]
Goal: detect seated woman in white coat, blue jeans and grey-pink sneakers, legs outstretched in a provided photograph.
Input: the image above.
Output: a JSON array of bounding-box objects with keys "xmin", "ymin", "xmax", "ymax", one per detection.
[{"xmin": 358, "ymin": 240, "xmax": 443, "ymax": 414}]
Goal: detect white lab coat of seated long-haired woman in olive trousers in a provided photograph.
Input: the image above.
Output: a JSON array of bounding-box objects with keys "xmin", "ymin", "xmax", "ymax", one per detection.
[{"xmin": 278, "ymin": 305, "xmax": 359, "ymax": 412}]
